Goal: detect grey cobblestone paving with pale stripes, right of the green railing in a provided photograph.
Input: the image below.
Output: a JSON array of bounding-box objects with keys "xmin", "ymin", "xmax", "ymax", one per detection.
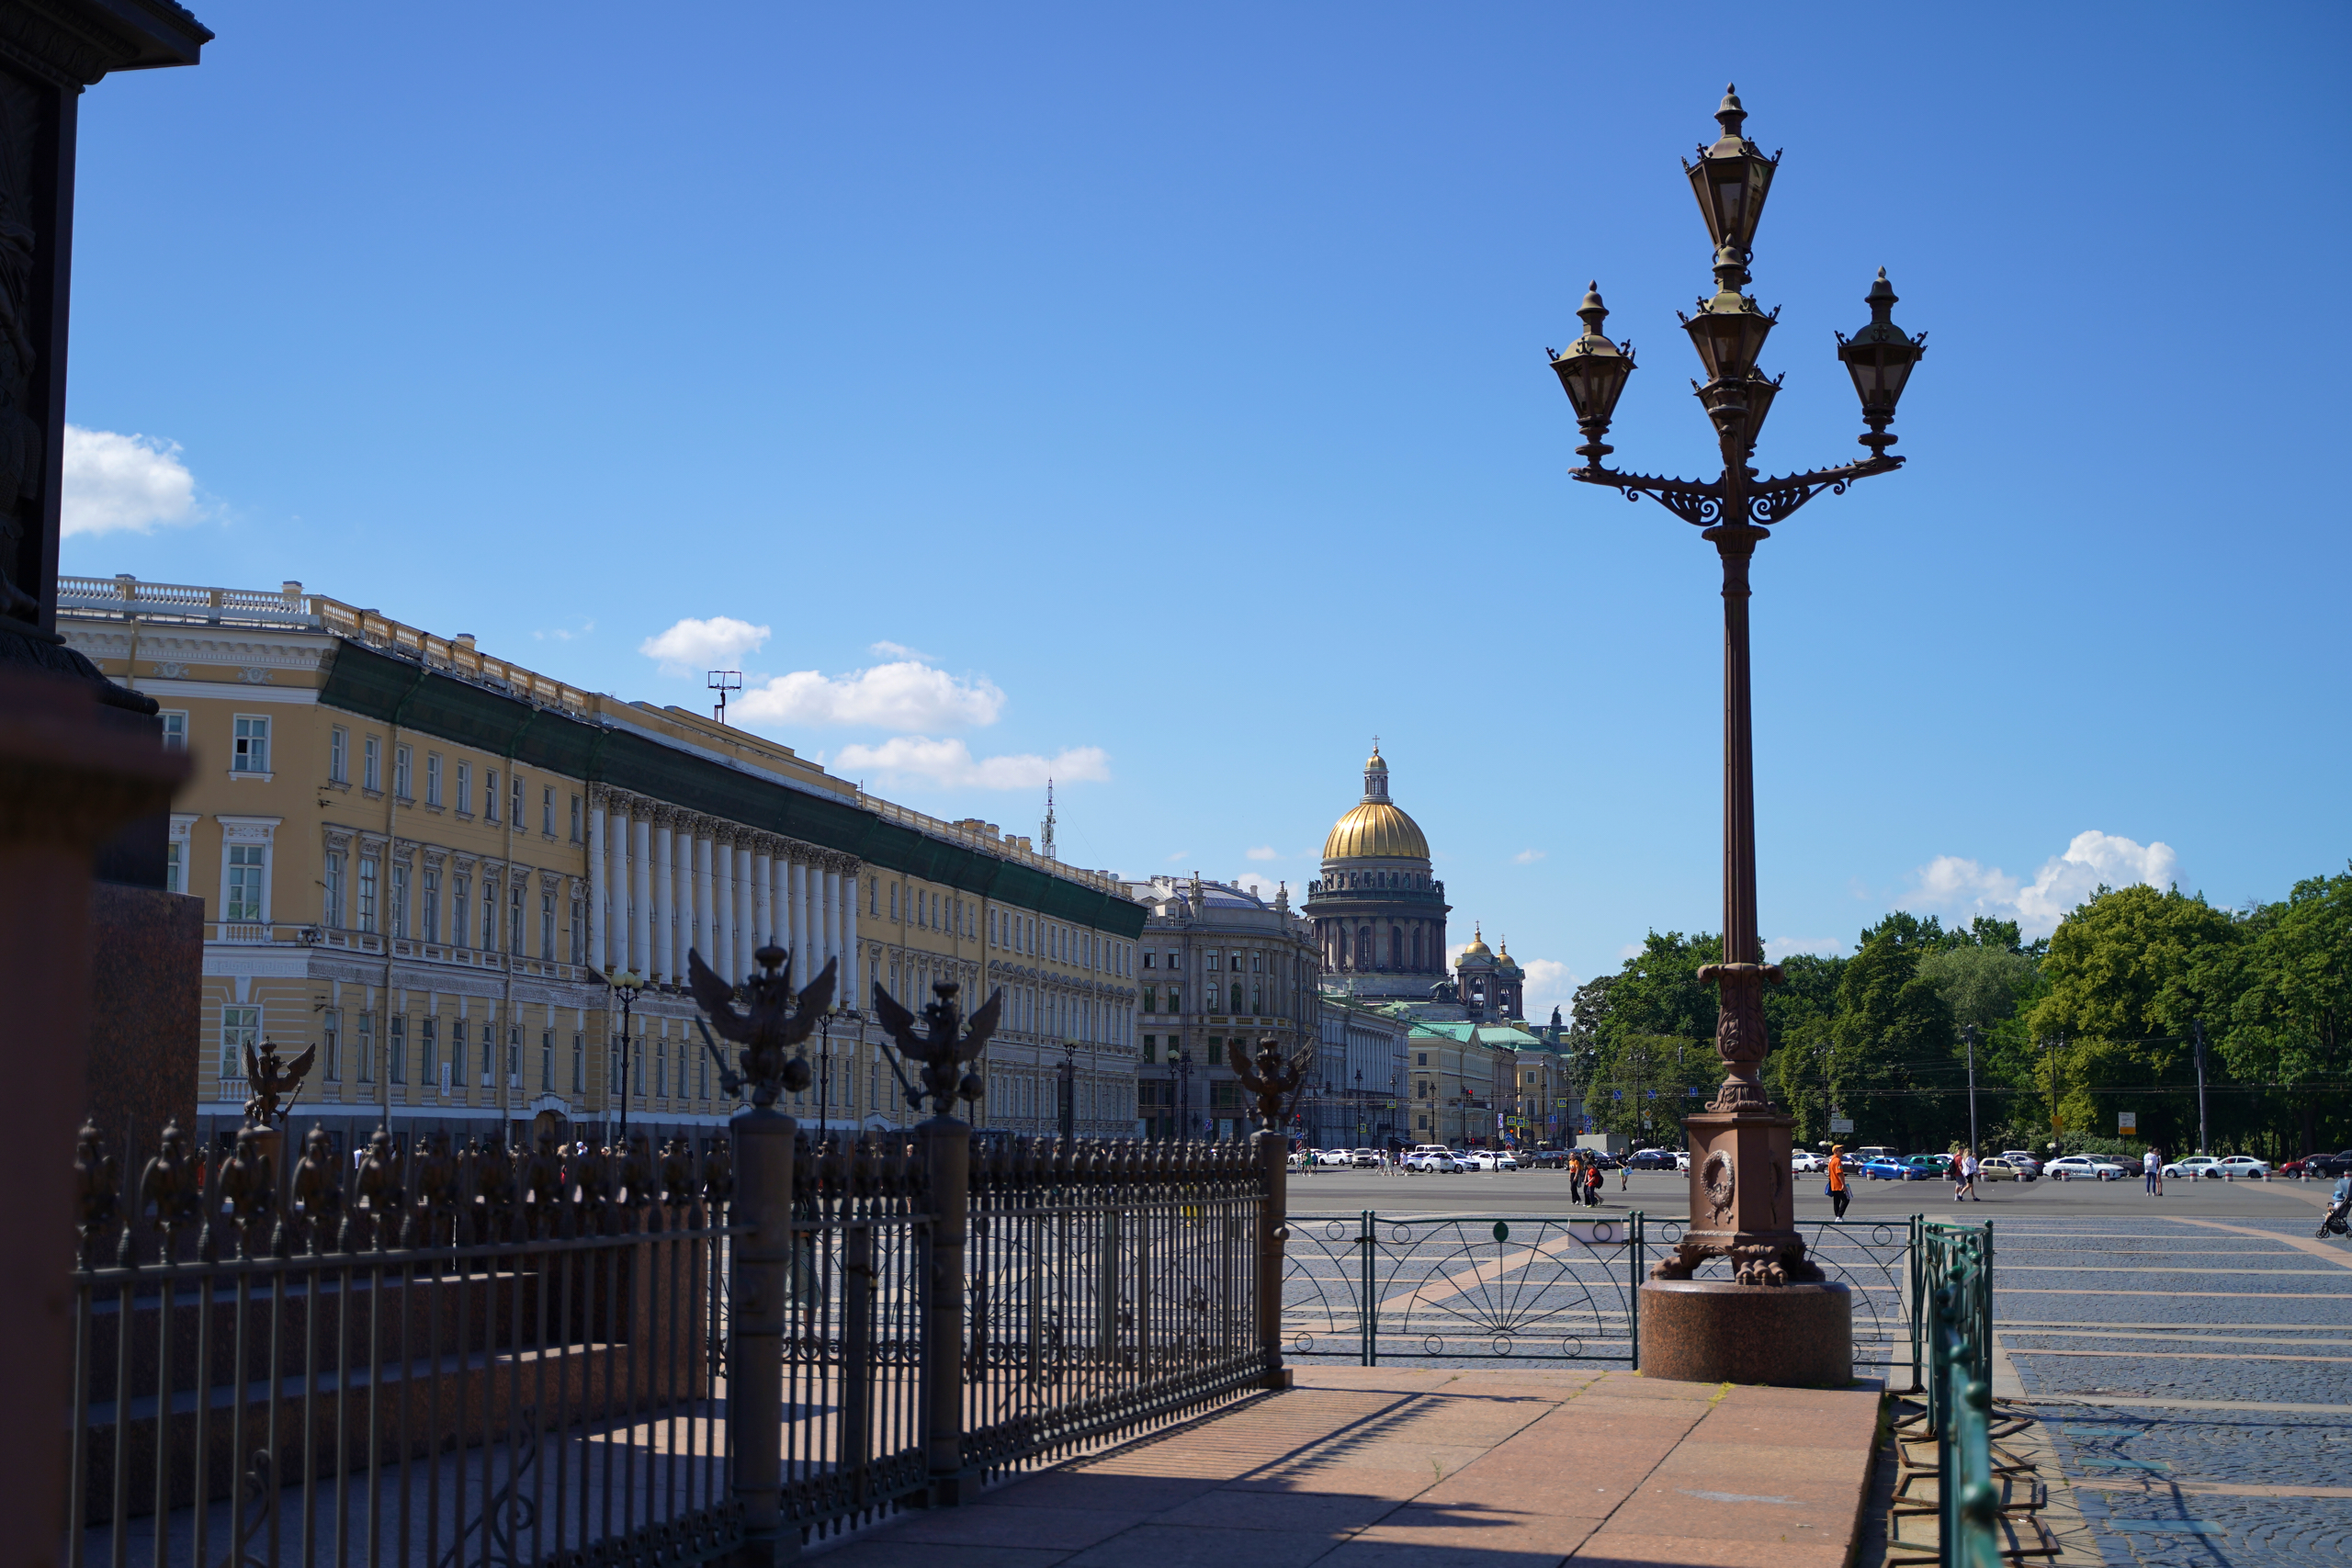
[{"xmin": 1969, "ymin": 1211, "xmax": 2352, "ymax": 1568}]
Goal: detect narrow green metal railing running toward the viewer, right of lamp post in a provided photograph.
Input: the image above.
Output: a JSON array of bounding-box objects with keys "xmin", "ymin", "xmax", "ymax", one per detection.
[{"xmin": 1912, "ymin": 1220, "xmax": 2002, "ymax": 1568}]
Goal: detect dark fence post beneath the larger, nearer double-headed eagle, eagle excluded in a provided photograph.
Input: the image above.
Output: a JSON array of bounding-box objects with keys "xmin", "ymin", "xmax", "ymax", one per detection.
[{"xmin": 727, "ymin": 1107, "xmax": 799, "ymax": 1568}]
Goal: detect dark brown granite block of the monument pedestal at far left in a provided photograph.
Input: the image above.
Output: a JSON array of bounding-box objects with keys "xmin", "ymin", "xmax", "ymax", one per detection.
[{"xmin": 85, "ymin": 882, "xmax": 205, "ymax": 1156}]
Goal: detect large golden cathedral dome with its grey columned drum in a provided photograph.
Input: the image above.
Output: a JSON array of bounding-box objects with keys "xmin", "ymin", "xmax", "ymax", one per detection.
[{"xmin": 1301, "ymin": 745, "xmax": 1449, "ymax": 1001}]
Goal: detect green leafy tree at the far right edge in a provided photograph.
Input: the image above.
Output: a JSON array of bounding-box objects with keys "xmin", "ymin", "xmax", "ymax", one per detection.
[{"xmin": 2221, "ymin": 867, "xmax": 2352, "ymax": 1152}]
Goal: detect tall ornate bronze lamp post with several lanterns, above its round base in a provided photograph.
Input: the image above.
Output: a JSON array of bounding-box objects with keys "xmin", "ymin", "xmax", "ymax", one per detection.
[{"xmin": 1553, "ymin": 89, "xmax": 1927, "ymax": 1378}]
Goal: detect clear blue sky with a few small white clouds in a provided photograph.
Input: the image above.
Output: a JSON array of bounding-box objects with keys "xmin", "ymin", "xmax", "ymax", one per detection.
[{"xmin": 66, "ymin": 5, "xmax": 2352, "ymax": 1020}]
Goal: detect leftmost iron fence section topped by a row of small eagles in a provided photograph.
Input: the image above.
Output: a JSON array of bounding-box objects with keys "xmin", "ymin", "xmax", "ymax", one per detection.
[{"xmin": 63, "ymin": 1126, "xmax": 736, "ymax": 1568}]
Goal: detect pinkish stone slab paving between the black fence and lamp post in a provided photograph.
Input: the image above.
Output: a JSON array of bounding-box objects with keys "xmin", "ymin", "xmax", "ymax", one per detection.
[{"xmin": 805, "ymin": 1366, "xmax": 1879, "ymax": 1568}]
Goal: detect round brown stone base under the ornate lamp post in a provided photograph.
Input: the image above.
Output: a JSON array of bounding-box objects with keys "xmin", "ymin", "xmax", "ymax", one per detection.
[{"xmin": 1642, "ymin": 1279, "xmax": 1853, "ymax": 1389}]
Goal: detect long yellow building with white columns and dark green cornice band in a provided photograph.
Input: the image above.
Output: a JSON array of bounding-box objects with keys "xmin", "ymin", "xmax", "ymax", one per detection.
[{"xmin": 59, "ymin": 579, "xmax": 1146, "ymax": 1147}]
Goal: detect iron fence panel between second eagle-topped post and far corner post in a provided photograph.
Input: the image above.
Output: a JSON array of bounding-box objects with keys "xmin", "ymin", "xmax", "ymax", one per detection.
[{"xmin": 962, "ymin": 1140, "xmax": 1282, "ymax": 1472}]
